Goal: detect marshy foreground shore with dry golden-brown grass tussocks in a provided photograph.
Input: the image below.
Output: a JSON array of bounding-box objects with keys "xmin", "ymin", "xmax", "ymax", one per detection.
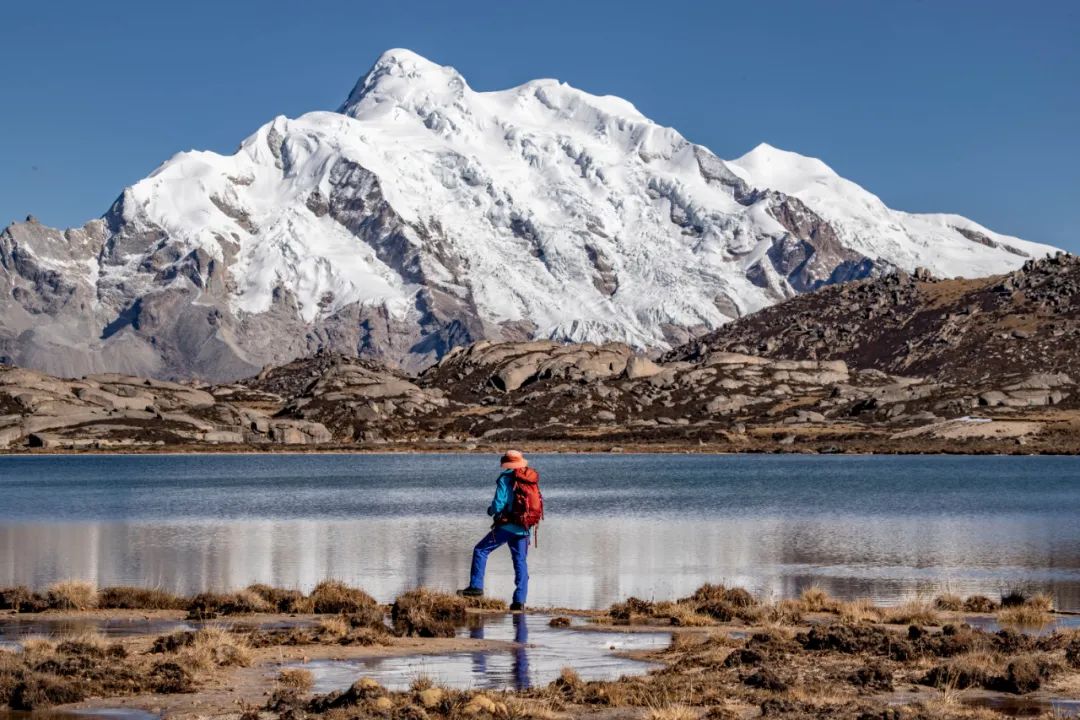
[{"xmin": 0, "ymin": 584, "xmax": 1080, "ymax": 720}]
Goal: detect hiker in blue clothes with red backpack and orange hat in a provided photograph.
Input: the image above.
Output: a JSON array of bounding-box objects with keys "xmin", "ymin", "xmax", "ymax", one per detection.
[{"xmin": 460, "ymin": 450, "xmax": 543, "ymax": 612}]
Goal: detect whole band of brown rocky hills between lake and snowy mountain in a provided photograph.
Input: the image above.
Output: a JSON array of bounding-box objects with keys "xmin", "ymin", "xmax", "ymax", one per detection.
[{"xmin": 8, "ymin": 255, "xmax": 1080, "ymax": 452}]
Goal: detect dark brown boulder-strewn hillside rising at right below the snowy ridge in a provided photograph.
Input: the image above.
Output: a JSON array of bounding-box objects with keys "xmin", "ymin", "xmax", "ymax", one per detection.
[{"xmin": 667, "ymin": 254, "xmax": 1080, "ymax": 383}]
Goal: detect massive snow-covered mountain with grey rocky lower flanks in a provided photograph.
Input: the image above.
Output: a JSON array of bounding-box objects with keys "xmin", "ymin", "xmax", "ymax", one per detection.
[{"xmin": 0, "ymin": 50, "xmax": 1054, "ymax": 379}]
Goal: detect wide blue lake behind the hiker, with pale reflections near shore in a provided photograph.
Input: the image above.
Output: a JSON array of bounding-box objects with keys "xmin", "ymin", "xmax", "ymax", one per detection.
[{"xmin": 0, "ymin": 454, "xmax": 1080, "ymax": 611}]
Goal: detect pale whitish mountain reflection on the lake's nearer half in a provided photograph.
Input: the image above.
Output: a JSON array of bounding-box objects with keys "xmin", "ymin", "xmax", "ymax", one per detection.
[{"xmin": 0, "ymin": 517, "xmax": 1080, "ymax": 610}]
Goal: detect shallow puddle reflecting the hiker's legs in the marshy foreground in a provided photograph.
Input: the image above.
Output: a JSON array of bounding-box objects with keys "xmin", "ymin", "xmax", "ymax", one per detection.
[{"xmin": 294, "ymin": 614, "xmax": 671, "ymax": 693}]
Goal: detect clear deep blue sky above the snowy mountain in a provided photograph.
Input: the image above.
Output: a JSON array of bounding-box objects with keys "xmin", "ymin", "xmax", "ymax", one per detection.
[{"xmin": 0, "ymin": 0, "xmax": 1080, "ymax": 252}]
